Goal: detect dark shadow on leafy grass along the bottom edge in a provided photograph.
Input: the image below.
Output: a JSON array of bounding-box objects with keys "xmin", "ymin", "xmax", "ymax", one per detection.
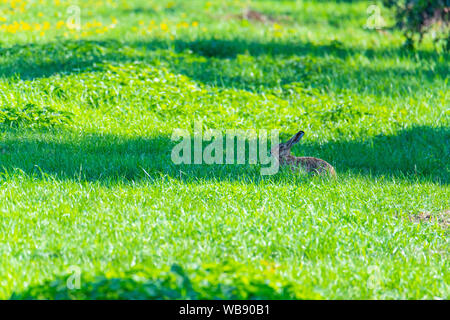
[{"xmin": 10, "ymin": 265, "xmax": 308, "ymax": 300}]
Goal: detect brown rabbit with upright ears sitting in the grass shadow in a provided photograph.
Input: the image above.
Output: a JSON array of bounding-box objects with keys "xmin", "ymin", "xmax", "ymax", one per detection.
[{"xmin": 270, "ymin": 131, "xmax": 336, "ymax": 177}]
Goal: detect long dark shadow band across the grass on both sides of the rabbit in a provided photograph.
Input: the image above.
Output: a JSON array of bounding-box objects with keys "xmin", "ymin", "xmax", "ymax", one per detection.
[{"xmin": 0, "ymin": 126, "xmax": 450, "ymax": 184}]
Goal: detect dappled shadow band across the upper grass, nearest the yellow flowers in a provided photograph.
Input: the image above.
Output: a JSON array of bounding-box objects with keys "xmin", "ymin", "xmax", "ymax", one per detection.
[{"xmin": 0, "ymin": 38, "xmax": 448, "ymax": 93}]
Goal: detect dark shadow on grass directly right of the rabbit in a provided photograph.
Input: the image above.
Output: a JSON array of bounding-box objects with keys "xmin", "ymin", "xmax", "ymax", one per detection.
[{"xmin": 294, "ymin": 126, "xmax": 450, "ymax": 184}]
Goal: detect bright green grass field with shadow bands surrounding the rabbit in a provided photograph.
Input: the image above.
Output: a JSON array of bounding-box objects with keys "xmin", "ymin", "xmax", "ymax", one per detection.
[{"xmin": 0, "ymin": 0, "xmax": 450, "ymax": 299}]
